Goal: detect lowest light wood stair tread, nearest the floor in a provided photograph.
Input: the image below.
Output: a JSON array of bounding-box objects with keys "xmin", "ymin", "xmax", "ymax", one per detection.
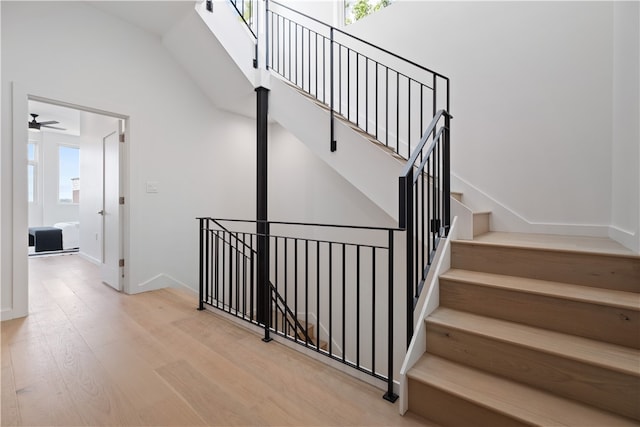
[{"xmin": 407, "ymin": 354, "xmax": 637, "ymax": 427}]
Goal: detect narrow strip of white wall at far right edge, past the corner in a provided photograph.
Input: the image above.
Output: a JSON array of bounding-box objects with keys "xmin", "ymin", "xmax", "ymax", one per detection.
[{"xmin": 611, "ymin": 2, "xmax": 640, "ymax": 252}]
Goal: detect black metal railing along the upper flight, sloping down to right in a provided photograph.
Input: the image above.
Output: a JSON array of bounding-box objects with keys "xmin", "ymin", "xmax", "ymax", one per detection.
[{"xmin": 265, "ymin": 0, "xmax": 449, "ymax": 159}]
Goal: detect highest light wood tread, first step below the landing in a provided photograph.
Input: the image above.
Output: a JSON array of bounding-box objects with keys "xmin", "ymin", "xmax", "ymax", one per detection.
[{"xmin": 440, "ymin": 269, "xmax": 640, "ymax": 311}]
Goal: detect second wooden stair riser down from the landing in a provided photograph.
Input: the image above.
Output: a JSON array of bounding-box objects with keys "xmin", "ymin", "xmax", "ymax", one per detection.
[{"xmin": 440, "ymin": 278, "xmax": 640, "ymax": 349}]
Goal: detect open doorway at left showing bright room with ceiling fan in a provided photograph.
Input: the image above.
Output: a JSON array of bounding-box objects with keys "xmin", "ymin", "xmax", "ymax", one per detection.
[{"xmin": 27, "ymin": 99, "xmax": 125, "ymax": 291}]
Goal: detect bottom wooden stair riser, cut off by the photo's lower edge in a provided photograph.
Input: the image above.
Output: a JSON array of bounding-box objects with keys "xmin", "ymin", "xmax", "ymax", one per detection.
[{"xmin": 409, "ymin": 379, "xmax": 529, "ymax": 427}]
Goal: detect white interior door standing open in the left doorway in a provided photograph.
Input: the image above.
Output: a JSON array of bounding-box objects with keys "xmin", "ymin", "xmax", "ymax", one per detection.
[{"xmin": 99, "ymin": 132, "xmax": 123, "ymax": 291}]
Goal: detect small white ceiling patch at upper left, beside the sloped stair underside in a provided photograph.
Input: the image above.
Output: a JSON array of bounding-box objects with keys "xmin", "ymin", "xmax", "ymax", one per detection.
[{"xmin": 86, "ymin": 0, "xmax": 196, "ymax": 37}]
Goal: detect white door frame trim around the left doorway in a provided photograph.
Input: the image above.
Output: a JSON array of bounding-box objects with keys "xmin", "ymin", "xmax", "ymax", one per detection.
[{"xmin": 8, "ymin": 82, "xmax": 131, "ymax": 320}]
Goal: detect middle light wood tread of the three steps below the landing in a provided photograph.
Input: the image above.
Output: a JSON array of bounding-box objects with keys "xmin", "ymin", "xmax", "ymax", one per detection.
[{"xmin": 426, "ymin": 307, "xmax": 640, "ymax": 377}]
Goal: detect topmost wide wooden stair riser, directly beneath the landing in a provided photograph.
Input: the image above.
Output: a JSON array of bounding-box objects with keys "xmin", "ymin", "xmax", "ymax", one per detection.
[{"xmin": 451, "ymin": 242, "xmax": 640, "ymax": 292}]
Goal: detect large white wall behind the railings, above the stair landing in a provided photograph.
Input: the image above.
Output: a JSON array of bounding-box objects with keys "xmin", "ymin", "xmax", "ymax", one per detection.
[{"xmin": 347, "ymin": 1, "xmax": 637, "ymax": 241}]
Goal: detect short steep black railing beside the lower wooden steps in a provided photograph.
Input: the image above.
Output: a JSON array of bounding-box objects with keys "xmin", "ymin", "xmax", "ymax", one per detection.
[{"xmin": 399, "ymin": 110, "xmax": 451, "ymax": 346}]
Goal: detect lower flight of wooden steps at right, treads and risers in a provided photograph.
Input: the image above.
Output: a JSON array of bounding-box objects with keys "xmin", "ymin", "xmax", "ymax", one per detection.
[{"xmin": 408, "ymin": 236, "xmax": 640, "ymax": 427}]
